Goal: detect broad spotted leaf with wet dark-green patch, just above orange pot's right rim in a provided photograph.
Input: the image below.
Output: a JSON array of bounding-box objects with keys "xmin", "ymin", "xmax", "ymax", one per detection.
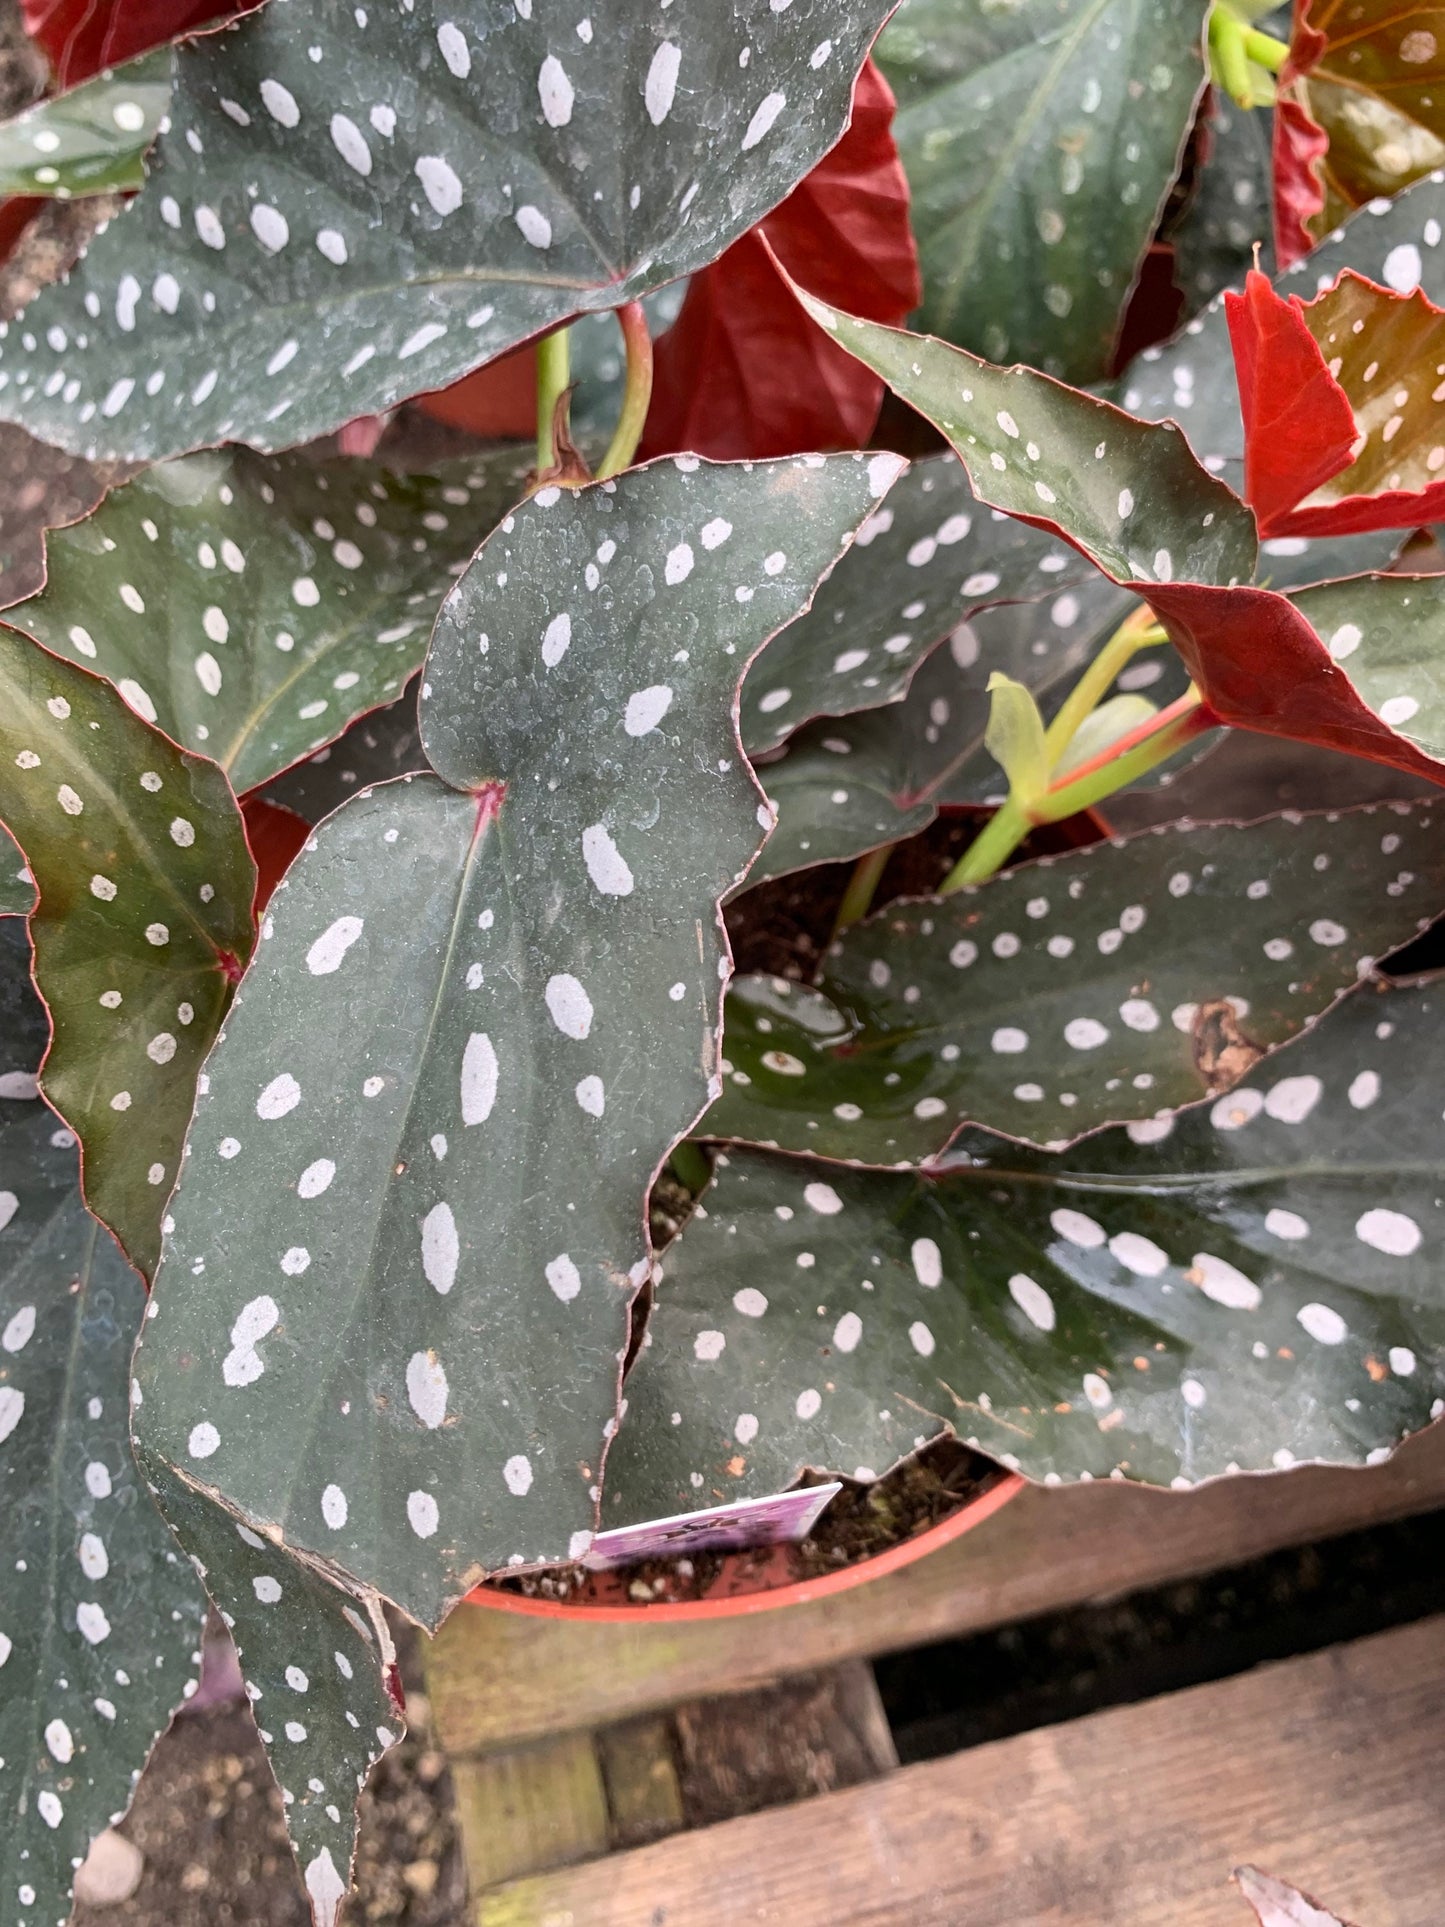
[{"xmin": 603, "ymin": 985, "xmax": 1445, "ymax": 1526}]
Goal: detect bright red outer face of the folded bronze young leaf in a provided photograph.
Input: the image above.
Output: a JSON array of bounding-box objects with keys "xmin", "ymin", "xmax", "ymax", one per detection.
[{"xmin": 1223, "ymin": 268, "xmax": 1356, "ymax": 536}]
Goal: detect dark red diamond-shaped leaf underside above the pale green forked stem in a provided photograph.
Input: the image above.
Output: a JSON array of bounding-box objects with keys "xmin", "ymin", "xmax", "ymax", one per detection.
[{"xmin": 1131, "ymin": 582, "xmax": 1445, "ymax": 784}]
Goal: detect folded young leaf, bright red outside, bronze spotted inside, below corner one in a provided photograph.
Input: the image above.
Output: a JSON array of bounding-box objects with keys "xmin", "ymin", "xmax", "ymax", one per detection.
[{"xmin": 1225, "ymin": 263, "xmax": 1445, "ymax": 536}]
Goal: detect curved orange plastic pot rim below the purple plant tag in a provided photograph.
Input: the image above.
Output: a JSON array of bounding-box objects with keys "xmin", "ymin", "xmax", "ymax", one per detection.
[{"xmin": 466, "ymin": 1472, "xmax": 1027, "ymax": 1626}]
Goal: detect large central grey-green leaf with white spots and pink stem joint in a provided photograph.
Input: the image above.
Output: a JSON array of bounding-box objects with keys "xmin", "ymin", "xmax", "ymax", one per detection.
[{"xmin": 139, "ymin": 455, "xmax": 900, "ymax": 1624}]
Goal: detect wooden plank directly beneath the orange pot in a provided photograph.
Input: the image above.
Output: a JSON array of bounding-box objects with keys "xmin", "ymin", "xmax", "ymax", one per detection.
[{"xmin": 428, "ymin": 1426, "xmax": 1445, "ymax": 1755}]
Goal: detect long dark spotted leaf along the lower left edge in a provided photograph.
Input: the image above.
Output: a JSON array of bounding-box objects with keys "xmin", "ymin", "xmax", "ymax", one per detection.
[{"xmin": 0, "ymin": 917, "xmax": 206, "ymax": 1927}]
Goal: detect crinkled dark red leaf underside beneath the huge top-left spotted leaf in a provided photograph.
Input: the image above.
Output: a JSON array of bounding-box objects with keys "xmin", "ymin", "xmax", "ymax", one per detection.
[{"xmin": 642, "ymin": 60, "xmax": 921, "ymax": 461}]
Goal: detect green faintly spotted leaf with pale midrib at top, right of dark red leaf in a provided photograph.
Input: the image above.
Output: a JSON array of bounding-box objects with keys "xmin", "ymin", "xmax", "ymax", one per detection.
[{"xmin": 879, "ymin": 0, "xmax": 1208, "ymax": 382}]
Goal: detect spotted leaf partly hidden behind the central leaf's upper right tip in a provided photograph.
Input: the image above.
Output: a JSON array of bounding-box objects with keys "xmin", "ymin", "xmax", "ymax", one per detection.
[{"xmin": 742, "ymin": 455, "xmax": 1094, "ymax": 755}]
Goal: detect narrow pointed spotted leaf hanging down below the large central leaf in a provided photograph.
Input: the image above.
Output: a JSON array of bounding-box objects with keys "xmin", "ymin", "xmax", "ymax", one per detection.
[{"xmin": 141, "ymin": 1455, "xmax": 401, "ymax": 1927}]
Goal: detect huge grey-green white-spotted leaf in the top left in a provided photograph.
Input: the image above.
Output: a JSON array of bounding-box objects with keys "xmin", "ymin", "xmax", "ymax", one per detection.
[{"xmin": 0, "ymin": 0, "xmax": 890, "ymax": 459}]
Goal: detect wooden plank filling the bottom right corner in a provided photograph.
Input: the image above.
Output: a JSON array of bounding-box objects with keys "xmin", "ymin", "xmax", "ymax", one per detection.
[{"xmin": 476, "ymin": 1617, "xmax": 1445, "ymax": 1927}]
